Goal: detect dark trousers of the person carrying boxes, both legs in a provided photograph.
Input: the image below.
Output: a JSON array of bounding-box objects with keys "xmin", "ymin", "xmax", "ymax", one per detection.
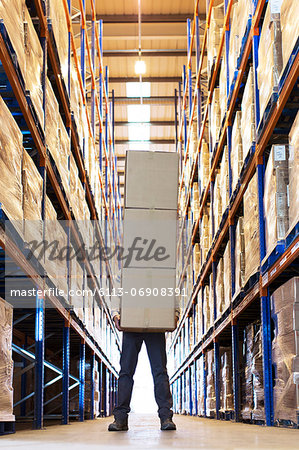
[{"xmin": 113, "ymin": 331, "xmax": 173, "ymax": 420}]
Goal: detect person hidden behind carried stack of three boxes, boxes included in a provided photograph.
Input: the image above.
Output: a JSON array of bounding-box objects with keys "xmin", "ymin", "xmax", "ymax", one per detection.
[{"xmin": 108, "ymin": 151, "xmax": 179, "ymax": 431}]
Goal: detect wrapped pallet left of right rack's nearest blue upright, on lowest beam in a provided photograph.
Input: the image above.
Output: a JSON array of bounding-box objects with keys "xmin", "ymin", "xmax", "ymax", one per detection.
[{"xmin": 244, "ymin": 173, "xmax": 260, "ymax": 283}]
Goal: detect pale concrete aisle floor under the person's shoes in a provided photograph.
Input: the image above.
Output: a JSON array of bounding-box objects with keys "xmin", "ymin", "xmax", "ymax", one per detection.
[{"xmin": 0, "ymin": 414, "xmax": 299, "ymax": 450}]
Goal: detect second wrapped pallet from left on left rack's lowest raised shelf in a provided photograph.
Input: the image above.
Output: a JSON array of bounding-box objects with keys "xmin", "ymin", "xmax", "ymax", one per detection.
[{"xmin": 22, "ymin": 150, "xmax": 43, "ymax": 243}]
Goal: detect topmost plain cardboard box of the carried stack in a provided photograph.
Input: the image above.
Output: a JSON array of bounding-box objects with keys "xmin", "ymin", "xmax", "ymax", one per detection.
[{"xmin": 125, "ymin": 150, "xmax": 179, "ymax": 210}]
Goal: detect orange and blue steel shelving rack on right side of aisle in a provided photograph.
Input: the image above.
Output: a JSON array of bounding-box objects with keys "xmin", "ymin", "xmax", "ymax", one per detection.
[{"xmin": 168, "ymin": 0, "xmax": 299, "ymax": 426}]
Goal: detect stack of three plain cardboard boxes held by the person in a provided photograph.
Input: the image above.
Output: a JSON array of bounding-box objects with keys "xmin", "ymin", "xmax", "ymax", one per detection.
[{"xmin": 120, "ymin": 151, "xmax": 178, "ymax": 332}]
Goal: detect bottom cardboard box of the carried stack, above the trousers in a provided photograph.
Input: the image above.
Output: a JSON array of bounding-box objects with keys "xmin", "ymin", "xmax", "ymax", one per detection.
[{"xmin": 120, "ymin": 268, "xmax": 175, "ymax": 332}]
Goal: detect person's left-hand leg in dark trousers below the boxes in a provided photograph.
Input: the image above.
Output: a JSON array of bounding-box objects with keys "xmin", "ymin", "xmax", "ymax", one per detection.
[{"xmin": 113, "ymin": 331, "xmax": 143, "ymax": 421}]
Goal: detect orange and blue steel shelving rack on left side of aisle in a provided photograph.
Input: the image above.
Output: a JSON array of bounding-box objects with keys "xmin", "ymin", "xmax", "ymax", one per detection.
[{"xmin": 0, "ymin": 0, "xmax": 122, "ymax": 432}]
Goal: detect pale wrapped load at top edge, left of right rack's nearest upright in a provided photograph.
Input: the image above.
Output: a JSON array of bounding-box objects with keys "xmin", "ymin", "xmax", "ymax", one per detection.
[{"xmin": 229, "ymin": 0, "xmax": 252, "ymax": 85}]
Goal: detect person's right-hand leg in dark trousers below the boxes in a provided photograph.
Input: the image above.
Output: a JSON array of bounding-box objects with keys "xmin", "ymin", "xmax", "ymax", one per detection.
[{"xmin": 144, "ymin": 333, "xmax": 173, "ymax": 421}]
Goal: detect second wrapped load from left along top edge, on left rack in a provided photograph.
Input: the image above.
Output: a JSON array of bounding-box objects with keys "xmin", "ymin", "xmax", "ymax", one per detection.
[{"xmin": 48, "ymin": 0, "xmax": 69, "ymax": 87}]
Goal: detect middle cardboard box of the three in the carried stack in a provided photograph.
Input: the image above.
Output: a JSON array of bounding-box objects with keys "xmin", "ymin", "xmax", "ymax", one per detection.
[{"xmin": 122, "ymin": 209, "xmax": 177, "ymax": 268}]
